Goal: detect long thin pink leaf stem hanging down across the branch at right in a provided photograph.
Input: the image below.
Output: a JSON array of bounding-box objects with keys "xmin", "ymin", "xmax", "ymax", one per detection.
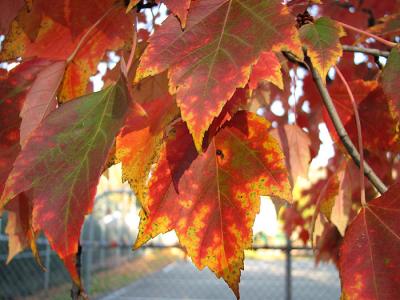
[{"xmin": 335, "ymin": 66, "xmax": 367, "ymax": 207}]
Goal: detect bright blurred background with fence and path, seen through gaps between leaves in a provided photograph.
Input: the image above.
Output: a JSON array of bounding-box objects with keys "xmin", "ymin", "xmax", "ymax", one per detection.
[{"xmin": 0, "ymin": 1, "xmax": 346, "ymax": 300}]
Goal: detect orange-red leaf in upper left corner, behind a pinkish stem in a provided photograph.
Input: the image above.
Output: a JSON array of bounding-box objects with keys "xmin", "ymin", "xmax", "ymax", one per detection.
[{"xmin": 0, "ymin": 1, "xmax": 133, "ymax": 102}]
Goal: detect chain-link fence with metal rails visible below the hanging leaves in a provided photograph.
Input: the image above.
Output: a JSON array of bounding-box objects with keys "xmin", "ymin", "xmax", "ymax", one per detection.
[{"xmin": 0, "ymin": 191, "xmax": 340, "ymax": 300}]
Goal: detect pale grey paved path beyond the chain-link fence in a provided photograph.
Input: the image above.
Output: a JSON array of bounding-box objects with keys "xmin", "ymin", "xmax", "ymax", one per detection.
[{"xmin": 101, "ymin": 259, "xmax": 340, "ymax": 300}]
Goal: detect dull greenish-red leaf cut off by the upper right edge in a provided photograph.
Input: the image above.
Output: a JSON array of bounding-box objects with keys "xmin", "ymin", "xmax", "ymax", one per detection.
[{"xmin": 381, "ymin": 48, "xmax": 400, "ymax": 113}]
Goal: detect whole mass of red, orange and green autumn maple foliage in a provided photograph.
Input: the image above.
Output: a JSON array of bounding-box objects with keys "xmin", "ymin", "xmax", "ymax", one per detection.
[{"xmin": 0, "ymin": 0, "xmax": 400, "ymax": 299}]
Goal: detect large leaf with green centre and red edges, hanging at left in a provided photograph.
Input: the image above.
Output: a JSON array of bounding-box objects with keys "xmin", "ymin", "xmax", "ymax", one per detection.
[{"xmin": 0, "ymin": 79, "xmax": 130, "ymax": 282}]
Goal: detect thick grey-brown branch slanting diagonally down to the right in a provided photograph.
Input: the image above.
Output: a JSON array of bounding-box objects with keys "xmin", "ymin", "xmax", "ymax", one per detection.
[{"xmin": 308, "ymin": 60, "xmax": 388, "ymax": 194}]
